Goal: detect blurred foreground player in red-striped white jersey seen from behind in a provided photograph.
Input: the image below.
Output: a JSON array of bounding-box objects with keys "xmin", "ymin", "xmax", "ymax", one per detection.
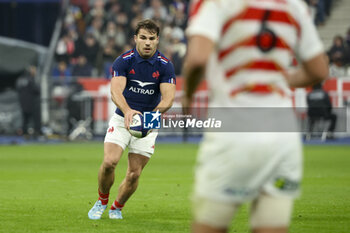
[{"xmin": 183, "ymin": 0, "xmax": 328, "ymax": 233}]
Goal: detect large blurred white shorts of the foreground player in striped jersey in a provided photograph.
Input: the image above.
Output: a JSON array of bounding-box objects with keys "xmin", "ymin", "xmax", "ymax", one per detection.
[{"xmin": 194, "ymin": 132, "xmax": 302, "ymax": 203}]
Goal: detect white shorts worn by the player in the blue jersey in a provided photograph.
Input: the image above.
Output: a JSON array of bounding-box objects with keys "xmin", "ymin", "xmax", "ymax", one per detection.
[{"xmin": 104, "ymin": 113, "xmax": 158, "ymax": 157}]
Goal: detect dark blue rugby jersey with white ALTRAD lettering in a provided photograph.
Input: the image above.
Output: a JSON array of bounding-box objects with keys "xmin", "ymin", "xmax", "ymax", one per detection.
[{"xmin": 112, "ymin": 48, "xmax": 176, "ymax": 116}]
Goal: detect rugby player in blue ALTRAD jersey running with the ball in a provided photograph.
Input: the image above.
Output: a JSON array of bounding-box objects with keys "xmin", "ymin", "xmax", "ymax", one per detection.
[{"xmin": 88, "ymin": 19, "xmax": 176, "ymax": 219}]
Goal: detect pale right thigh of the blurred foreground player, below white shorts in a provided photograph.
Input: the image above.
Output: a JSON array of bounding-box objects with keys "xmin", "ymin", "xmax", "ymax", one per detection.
[{"xmin": 250, "ymin": 194, "xmax": 294, "ymax": 229}]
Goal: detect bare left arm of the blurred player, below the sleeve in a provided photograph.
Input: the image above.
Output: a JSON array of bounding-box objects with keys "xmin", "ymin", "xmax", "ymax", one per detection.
[{"xmin": 183, "ymin": 35, "xmax": 214, "ymax": 104}]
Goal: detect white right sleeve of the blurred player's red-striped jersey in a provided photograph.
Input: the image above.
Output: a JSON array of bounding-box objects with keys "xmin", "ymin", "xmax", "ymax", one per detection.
[{"xmin": 296, "ymin": 1, "xmax": 324, "ymax": 61}]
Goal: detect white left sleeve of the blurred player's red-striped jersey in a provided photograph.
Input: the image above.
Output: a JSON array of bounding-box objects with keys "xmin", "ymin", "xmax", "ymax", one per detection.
[{"xmin": 186, "ymin": 0, "xmax": 223, "ymax": 42}]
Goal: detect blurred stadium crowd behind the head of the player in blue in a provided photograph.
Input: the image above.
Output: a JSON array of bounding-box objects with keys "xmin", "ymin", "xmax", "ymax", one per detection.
[{"xmin": 52, "ymin": 0, "xmax": 188, "ymax": 83}]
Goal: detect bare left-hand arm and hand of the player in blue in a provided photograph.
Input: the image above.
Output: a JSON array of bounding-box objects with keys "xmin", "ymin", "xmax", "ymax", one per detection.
[{"xmin": 111, "ymin": 76, "xmax": 141, "ymax": 128}]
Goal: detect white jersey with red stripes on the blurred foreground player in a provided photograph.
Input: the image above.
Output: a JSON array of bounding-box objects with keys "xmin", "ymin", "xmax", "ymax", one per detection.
[{"xmin": 186, "ymin": 0, "xmax": 323, "ymax": 106}]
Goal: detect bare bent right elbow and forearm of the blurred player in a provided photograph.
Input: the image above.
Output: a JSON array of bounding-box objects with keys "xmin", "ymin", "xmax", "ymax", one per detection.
[{"xmin": 287, "ymin": 53, "xmax": 328, "ymax": 87}]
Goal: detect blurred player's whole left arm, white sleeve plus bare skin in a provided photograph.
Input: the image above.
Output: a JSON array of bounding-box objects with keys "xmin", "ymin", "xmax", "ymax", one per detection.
[{"xmin": 182, "ymin": 1, "xmax": 223, "ymax": 112}]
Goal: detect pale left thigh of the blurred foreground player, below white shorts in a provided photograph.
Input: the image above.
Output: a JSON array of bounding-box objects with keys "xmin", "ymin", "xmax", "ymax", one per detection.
[{"xmin": 192, "ymin": 196, "xmax": 240, "ymax": 229}]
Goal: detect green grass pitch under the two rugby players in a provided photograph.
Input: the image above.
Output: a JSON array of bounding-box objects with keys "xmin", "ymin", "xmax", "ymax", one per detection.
[{"xmin": 0, "ymin": 143, "xmax": 350, "ymax": 233}]
